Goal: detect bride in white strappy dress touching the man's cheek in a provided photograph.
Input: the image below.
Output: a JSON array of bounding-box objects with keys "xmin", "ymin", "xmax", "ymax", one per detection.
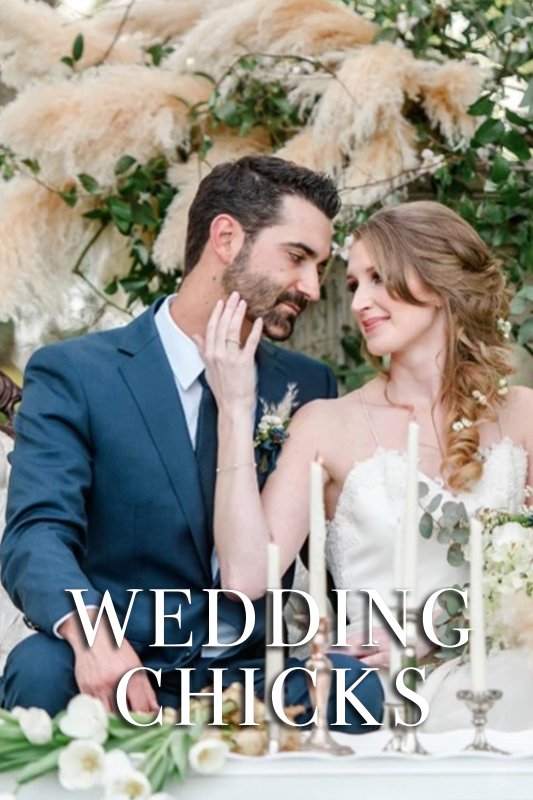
[{"xmin": 201, "ymin": 202, "xmax": 533, "ymax": 730}]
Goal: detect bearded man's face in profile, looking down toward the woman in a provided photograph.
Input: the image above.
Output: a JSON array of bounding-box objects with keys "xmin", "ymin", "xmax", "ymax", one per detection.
[{"xmin": 222, "ymin": 195, "xmax": 331, "ymax": 342}]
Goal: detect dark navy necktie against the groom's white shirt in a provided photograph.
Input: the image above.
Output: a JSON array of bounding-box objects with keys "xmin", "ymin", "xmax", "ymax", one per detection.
[{"xmin": 195, "ymin": 372, "xmax": 217, "ymax": 542}]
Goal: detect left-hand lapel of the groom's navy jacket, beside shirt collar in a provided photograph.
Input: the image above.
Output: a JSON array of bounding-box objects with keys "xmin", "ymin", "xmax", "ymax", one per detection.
[{"xmin": 119, "ymin": 306, "xmax": 211, "ymax": 585}]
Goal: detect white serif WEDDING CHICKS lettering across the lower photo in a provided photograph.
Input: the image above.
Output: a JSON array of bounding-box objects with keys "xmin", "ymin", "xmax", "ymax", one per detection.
[{"xmin": 65, "ymin": 588, "xmax": 469, "ymax": 727}]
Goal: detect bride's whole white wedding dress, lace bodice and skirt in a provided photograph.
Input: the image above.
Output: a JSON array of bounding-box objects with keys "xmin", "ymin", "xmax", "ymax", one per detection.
[{"xmin": 326, "ymin": 428, "xmax": 533, "ymax": 731}]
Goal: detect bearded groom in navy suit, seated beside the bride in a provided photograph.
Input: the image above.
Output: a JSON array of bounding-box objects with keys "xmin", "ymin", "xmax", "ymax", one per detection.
[{"xmin": 0, "ymin": 156, "xmax": 381, "ymax": 732}]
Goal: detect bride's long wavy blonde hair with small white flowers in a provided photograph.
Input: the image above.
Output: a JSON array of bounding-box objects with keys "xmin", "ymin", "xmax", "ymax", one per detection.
[{"xmin": 357, "ymin": 201, "xmax": 513, "ymax": 490}]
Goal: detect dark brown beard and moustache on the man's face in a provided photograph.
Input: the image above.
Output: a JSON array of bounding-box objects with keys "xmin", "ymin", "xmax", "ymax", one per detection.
[{"xmin": 222, "ymin": 241, "xmax": 307, "ymax": 342}]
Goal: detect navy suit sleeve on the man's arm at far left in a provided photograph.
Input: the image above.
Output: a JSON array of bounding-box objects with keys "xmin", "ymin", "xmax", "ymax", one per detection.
[{"xmin": 0, "ymin": 346, "xmax": 102, "ymax": 634}]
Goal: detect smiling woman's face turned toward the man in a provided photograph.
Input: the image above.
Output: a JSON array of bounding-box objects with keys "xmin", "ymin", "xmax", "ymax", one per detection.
[{"xmin": 346, "ymin": 240, "xmax": 443, "ymax": 356}]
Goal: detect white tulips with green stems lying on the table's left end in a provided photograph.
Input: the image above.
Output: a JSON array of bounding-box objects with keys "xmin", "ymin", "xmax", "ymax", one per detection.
[{"xmin": 0, "ymin": 684, "xmax": 304, "ymax": 800}]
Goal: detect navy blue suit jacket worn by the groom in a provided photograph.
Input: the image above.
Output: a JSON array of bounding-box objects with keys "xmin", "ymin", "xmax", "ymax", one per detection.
[{"xmin": 0, "ymin": 303, "xmax": 336, "ymax": 670}]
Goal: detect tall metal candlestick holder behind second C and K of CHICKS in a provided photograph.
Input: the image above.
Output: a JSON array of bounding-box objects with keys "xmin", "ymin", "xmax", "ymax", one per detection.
[{"xmin": 300, "ymin": 617, "xmax": 355, "ymax": 756}]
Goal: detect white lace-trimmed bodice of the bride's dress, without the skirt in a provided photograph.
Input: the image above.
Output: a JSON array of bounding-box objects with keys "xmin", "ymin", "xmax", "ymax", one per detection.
[{"xmin": 326, "ymin": 437, "xmax": 527, "ymax": 630}]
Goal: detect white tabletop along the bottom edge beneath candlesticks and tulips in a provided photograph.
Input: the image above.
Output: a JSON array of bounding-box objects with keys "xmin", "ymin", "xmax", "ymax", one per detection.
[{"xmin": 0, "ymin": 730, "xmax": 533, "ymax": 800}]
